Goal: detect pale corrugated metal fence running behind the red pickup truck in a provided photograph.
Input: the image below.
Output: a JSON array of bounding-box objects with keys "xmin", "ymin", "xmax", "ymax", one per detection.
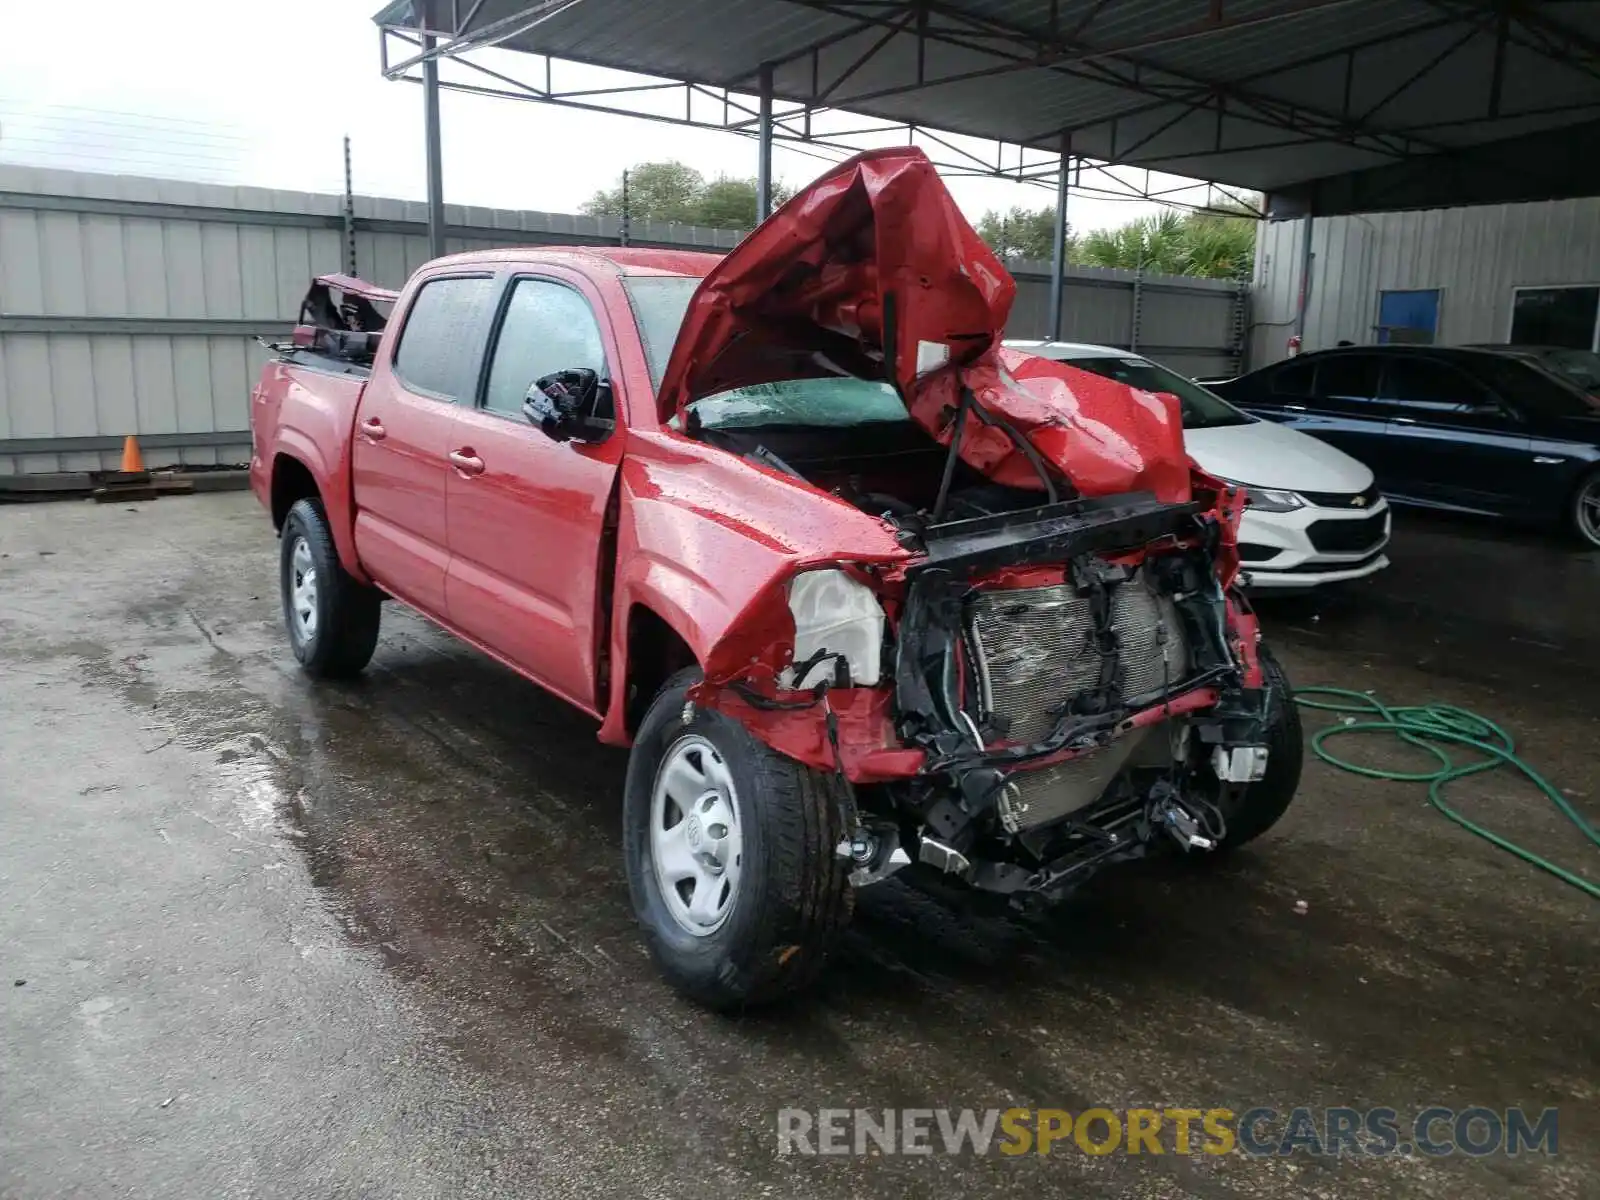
[{"xmin": 0, "ymin": 166, "xmax": 1243, "ymax": 477}]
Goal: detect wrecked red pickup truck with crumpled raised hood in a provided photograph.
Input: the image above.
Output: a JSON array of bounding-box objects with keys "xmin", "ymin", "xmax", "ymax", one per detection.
[{"xmin": 251, "ymin": 149, "xmax": 1301, "ymax": 1008}]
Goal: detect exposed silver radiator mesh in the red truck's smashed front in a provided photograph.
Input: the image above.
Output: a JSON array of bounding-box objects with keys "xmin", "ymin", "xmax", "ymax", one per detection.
[{"xmin": 971, "ymin": 571, "xmax": 1189, "ymax": 742}]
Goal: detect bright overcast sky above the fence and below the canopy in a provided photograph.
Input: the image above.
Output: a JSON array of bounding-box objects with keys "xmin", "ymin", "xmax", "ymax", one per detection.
[{"xmin": 0, "ymin": 0, "xmax": 1222, "ymax": 230}]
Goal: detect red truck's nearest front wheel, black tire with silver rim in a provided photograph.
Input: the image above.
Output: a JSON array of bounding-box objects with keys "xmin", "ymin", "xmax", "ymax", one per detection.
[{"xmin": 622, "ymin": 670, "xmax": 853, "ymax": 1010}]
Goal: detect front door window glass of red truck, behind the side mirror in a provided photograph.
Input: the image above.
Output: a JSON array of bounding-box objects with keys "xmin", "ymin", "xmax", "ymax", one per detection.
[{"xmin": 483, "ymin": 278, "xmax": 611, "ymax": 418}]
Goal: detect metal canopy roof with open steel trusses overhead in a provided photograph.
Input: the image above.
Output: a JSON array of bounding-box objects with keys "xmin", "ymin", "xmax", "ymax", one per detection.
[{"xmin": 376, "ymin": 0, "xmax": 1600, "ymax": 216}]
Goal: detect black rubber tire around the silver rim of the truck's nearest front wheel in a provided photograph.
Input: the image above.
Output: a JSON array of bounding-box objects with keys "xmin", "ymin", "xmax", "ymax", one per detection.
[{"xmin": 622, "ymin": 669, "xmax": 854, "ymax": 1011}]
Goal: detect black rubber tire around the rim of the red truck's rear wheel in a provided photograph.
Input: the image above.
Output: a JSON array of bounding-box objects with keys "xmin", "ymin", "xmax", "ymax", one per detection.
[{"xmin": 278, "ymin": 498, "xmax": 382, "ymax": 678}]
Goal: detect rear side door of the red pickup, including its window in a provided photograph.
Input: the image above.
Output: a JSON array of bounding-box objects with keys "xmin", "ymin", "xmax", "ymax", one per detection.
[{"xmin": 350, "ymin": 275, "xmax": 494, "ymax": 614}]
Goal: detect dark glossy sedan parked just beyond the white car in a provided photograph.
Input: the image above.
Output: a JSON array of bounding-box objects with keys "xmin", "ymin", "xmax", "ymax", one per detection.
[{"xmin": 1210, "ymin": 346, "xmax": 1600, "ymax": 547}]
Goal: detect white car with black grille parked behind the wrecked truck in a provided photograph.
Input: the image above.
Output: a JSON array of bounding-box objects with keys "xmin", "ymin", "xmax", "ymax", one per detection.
[{"xmin": 1006, "ymin": 339, "xmax": 1389, "ymax": 590}]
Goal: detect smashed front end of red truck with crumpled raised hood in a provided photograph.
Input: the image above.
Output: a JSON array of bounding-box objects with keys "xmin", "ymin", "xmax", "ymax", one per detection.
[{"xmin": 643, "ymin": 149, "xmax": 1299, "ymax": 921}]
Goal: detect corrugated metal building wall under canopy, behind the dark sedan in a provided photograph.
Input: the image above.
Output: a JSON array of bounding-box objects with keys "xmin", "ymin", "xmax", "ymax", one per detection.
[{"xmin": 1250, "ymin": 198, "xmax": 1600, "ymax": 366}]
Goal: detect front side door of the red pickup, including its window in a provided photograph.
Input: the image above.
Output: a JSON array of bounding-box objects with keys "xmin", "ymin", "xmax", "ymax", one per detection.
[{"xmin": 446, "ymin": 278, "xmax": 622, "ymax": 710}]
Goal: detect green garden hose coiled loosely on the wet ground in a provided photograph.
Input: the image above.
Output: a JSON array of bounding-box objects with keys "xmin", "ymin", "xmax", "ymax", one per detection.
[{"xmin": 1294, "ymin": 688, "xmax": 1600, "ymax": 899}]
